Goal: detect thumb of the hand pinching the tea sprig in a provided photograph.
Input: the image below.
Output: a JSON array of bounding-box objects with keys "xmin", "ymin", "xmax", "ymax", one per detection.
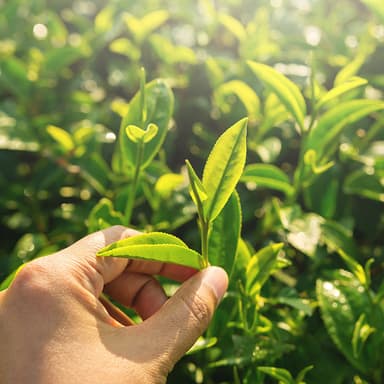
[{"xmin": 143, "ymin": 267, "xmax": 228, "ymax": 370}]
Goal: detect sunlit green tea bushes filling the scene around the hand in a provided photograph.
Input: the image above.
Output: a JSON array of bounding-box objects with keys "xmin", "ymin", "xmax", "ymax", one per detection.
[{"xmin": 0, "ymin": 0, "xmax": 384, "ymax": 384}]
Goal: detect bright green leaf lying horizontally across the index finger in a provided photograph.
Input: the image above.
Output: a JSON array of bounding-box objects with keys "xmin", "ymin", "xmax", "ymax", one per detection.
[{"xmin": 97, "ymin": 232, "xmax": 205, "ymax": 269}]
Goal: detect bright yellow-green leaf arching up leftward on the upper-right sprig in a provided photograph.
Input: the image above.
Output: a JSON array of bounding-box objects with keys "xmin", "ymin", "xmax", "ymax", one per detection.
[{"xmin": 247, "ymin": 61, "xmax": 306, "ymax": 131}]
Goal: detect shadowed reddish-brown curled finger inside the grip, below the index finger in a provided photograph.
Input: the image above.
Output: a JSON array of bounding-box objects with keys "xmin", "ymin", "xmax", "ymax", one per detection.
[{"xmin": 104, "ymin": 271, "xmax": 167, "ymax": 320}]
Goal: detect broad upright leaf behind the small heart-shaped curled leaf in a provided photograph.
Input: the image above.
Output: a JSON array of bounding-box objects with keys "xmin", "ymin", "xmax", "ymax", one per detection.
[{"xmin": 119, "ymin": 80, "xmax": 173, "ymax": 173}]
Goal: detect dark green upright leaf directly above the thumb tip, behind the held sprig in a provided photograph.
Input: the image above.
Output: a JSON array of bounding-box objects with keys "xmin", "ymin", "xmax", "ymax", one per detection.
[{"xmin": 208, "ymin": 191, "xmax": 241, "ymax": 276}]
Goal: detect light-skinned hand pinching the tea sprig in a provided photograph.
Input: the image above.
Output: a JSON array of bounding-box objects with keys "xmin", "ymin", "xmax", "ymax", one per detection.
[{"xmin": 0, "ymin": 226, "xmax": 228, "ymax": 384}]
